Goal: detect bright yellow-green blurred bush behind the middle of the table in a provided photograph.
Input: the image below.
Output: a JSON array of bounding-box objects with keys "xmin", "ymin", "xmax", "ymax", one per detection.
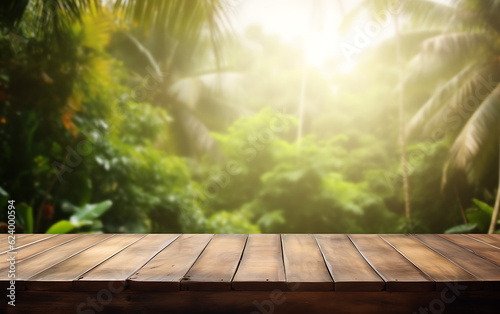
[{"xmin": 203, "ymin": 109, "xmax": 393, "ymax": 232}]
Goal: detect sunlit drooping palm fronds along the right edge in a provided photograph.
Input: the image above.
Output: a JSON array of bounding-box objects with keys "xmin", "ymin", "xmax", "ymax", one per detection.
[{"xmin": 405, "ymin": 0, "xmax": 500, "ymax": 233}]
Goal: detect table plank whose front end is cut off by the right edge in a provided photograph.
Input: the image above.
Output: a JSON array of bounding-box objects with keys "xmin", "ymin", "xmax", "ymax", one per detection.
[{"xmin": 415, "ymin": 234, "xmax": 500, "ymax": 290}]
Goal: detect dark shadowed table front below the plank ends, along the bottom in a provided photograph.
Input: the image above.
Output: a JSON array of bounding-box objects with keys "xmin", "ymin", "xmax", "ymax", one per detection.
[{"xmin": 6, "ymin": 290, "xmax": 498, "ymax": 314}]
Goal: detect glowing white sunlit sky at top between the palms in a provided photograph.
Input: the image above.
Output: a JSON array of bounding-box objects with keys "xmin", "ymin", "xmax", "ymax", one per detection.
[{"xmin": 228, "ymin": 0, "xmax": 451, "ymax": 71}]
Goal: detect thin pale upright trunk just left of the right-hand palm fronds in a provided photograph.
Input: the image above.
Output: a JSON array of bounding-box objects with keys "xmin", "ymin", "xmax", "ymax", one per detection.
[{"xmin": 394, "ymin": 14, "xmax": 411, "ymax": 219}]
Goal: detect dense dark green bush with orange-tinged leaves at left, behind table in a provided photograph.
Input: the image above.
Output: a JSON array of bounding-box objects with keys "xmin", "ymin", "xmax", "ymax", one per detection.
[{"xmin": 0, "ymin": 6, "xmax": 209, "ymax": 233}]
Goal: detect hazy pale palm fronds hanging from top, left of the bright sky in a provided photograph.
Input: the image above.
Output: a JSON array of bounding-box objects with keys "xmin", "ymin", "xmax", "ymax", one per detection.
[{"xmin": 109, "ymin": 0, "xmax": 239, "ymax": 157}]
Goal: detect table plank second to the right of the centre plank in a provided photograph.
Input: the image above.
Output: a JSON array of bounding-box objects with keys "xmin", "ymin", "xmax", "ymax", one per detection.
[{"xmin": 315, "ymin": 234, "xmax": 385, "ymax": 291}]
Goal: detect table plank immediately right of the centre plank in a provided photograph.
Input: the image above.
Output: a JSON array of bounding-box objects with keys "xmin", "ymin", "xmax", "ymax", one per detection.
[{"xmin": 281, "ymin": 234, "xmax": 333, "ymax": 291}]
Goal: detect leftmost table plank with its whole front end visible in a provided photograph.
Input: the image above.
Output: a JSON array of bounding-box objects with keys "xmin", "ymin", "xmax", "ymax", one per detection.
[{"xmin": 26, "ymin": 234, "xmax": 144, "ymax": 290}]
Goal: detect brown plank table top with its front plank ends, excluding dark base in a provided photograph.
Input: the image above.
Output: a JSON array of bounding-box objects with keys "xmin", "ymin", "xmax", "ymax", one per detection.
[{"xmin": 0, "ymin": 234, "xmax": 500, "ymax": 292}]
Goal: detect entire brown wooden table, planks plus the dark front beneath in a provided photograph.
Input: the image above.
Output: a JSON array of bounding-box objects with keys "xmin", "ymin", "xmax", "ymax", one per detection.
[{"xmin": 0, "ymin": 234, "xmax": 500, "ymax": 313}]
